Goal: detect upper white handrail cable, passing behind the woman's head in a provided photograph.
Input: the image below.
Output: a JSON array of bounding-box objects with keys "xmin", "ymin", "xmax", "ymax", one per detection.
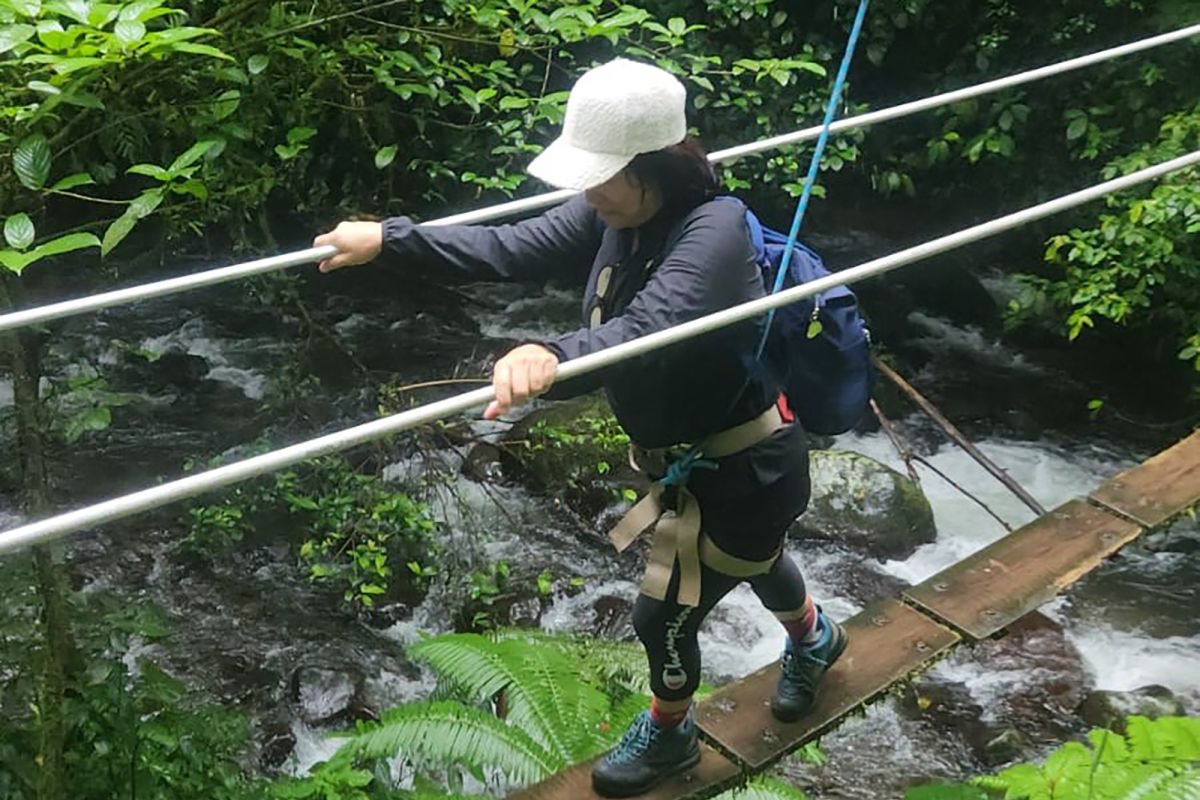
[{"xmin": 0, "ymin": 24, "xmax": 1200, "ymax": 332}]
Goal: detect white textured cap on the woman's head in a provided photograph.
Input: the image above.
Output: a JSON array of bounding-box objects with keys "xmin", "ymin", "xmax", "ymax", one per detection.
[{"xmin": 529, "ymin": 59, "xmax": 688, "ymax": 191}]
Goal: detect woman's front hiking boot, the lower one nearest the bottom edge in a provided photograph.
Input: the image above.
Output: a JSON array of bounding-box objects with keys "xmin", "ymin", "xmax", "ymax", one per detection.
[{"xmin": 592, "ymin": 710, "xmax": 700, "ymax": 798}]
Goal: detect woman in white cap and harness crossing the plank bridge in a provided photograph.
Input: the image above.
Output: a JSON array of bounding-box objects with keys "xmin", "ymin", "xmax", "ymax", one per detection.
[{"xmin": 314, "ymin": 59, "xmax": 846, "ymax": 796}]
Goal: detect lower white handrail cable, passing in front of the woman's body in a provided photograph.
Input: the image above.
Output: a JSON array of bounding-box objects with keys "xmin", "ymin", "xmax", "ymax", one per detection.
[{"xmin": 0, "ymin": 150, "xmax": 1200, "ymax": 554}]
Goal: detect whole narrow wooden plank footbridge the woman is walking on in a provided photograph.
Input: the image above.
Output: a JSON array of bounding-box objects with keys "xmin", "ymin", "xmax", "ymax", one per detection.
[{"xmin": 509, "ymin": 431, "xmax": 1200, "ymax": 800}]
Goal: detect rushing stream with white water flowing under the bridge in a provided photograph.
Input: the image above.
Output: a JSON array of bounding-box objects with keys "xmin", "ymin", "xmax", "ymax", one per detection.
[{"xmin": 0, "ymin": 241, "xmax": 1200, "ymax": 800}]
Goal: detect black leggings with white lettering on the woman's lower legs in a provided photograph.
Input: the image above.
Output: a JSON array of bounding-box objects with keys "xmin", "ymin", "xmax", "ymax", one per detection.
[{"xmin": 634, "ymin": 553, "xmax": 806, "ymax": 700}]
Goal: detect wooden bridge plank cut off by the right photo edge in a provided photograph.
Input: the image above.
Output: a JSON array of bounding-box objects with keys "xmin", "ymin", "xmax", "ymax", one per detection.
[{"xmin": 1092, "ymin": 431, "xmax": 1200, "ymax": 528}]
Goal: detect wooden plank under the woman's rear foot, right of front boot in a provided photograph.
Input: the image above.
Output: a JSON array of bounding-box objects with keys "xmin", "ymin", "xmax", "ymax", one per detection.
[{"xmin": 696, "ymin": 600, "xmax": 959, "ymax": 770}]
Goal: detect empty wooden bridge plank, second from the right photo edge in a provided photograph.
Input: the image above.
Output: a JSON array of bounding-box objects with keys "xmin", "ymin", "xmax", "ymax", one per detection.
[{"xmin": 905, "ymin": 500, "xmax": 1142, "ymax": 639}]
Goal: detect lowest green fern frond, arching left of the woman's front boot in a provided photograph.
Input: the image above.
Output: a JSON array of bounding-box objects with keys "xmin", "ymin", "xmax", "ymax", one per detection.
[{"xmin": 338, "ymin": 702, "xmax": 566, "ymax": 783}]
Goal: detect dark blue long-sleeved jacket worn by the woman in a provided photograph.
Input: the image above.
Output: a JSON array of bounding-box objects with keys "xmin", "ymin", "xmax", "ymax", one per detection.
[{"xmin": 383, "ymin": 197, "xmax": 779, "ymax": 447}]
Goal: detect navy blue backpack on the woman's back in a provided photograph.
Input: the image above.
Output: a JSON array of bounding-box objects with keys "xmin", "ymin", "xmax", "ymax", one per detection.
[{"xmin": 746, "ymin": 200, "xmax": 875, "ymax": 435}]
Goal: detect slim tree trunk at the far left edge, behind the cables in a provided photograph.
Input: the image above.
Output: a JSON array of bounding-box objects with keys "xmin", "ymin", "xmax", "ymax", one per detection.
[{"xmin": 0, "ymin": 276, "xmax": 74, "ymax": 800}]
